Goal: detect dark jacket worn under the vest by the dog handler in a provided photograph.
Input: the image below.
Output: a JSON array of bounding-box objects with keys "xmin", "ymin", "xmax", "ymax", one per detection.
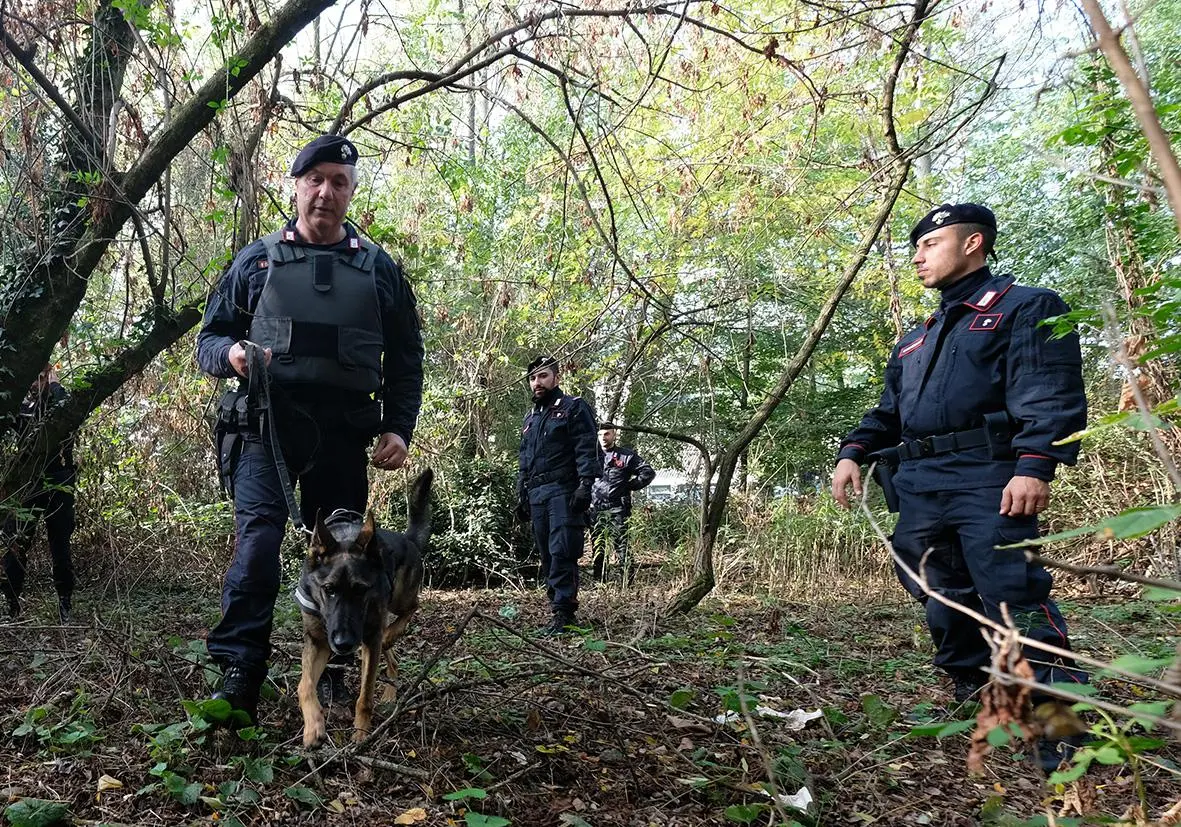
[{"xmin": 197, "ymin": 221, "xmax": 423, "ymax": 445}]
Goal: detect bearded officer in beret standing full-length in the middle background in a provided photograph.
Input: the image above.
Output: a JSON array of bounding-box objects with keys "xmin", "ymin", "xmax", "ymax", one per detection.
[{"xmin": 517, "ymin": 356, "xmax": 601, "ymax": 634}]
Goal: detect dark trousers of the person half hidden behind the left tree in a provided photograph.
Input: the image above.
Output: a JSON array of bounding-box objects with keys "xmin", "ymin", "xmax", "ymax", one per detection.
[{"xmin": 4, "ymin": 468, "xmax": 77, "ymax": 600}]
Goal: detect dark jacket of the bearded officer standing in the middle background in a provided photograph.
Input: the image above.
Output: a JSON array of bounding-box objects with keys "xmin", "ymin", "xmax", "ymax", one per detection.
[{"xmin": 517, "ymin": 388, "xmax": 602, "ymax": 504}]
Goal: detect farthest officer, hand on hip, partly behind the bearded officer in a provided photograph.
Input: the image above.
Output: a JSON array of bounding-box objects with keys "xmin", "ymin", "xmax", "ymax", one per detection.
[{"xmin": 591, "ymin": 422, "xmax": 657, "ymax": 582}]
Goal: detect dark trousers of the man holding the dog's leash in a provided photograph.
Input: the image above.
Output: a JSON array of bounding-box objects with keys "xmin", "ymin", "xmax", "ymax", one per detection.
[{"xmin": 205, "ymin": 432, "xmax": 368, "ymax": 671}]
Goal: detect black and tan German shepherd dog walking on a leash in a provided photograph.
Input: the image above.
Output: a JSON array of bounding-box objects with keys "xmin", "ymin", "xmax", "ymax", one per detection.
[{"xmin": 296, "ymin": 468, "xmax": 435, "ymax": 747}]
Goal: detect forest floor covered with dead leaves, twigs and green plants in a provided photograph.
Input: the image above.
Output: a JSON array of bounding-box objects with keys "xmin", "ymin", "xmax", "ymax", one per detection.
[{"xmin": 0, "ymin": 573, "xmax": 1181, "ymax": 827}]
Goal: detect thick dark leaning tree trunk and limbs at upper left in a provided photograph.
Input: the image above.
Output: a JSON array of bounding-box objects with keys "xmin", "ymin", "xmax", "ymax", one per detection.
[{"xmin": 0, "ymin": 0, "xmax": 332, "ymax": 487}]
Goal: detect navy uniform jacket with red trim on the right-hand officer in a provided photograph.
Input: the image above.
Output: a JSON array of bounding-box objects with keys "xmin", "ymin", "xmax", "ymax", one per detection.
[{"xmin": 839, "ymin": 267, "xmax": 1087, "ymax": 493}]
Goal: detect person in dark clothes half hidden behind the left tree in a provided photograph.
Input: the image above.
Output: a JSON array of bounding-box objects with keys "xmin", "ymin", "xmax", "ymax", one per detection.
[{"xmin": 0, "ymin": 365, "xmax": 78, "ymax": 624}]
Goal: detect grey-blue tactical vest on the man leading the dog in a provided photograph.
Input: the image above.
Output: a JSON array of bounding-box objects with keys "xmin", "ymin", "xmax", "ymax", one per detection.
[{"xmin": 248, "ymin": 229, "xmax": 385, "ymax": 393}]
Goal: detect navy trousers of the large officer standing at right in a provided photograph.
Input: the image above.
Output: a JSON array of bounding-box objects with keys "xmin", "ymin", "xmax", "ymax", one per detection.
[{"xmin": 893, "ymin": 487, "xmax": 1087, "ymax": 683}]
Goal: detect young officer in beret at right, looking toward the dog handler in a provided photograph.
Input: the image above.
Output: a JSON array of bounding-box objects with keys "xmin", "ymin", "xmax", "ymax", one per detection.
[{"xmin": 833, "ymin": 203, "xmax": 1087, "ymax": 767}]
